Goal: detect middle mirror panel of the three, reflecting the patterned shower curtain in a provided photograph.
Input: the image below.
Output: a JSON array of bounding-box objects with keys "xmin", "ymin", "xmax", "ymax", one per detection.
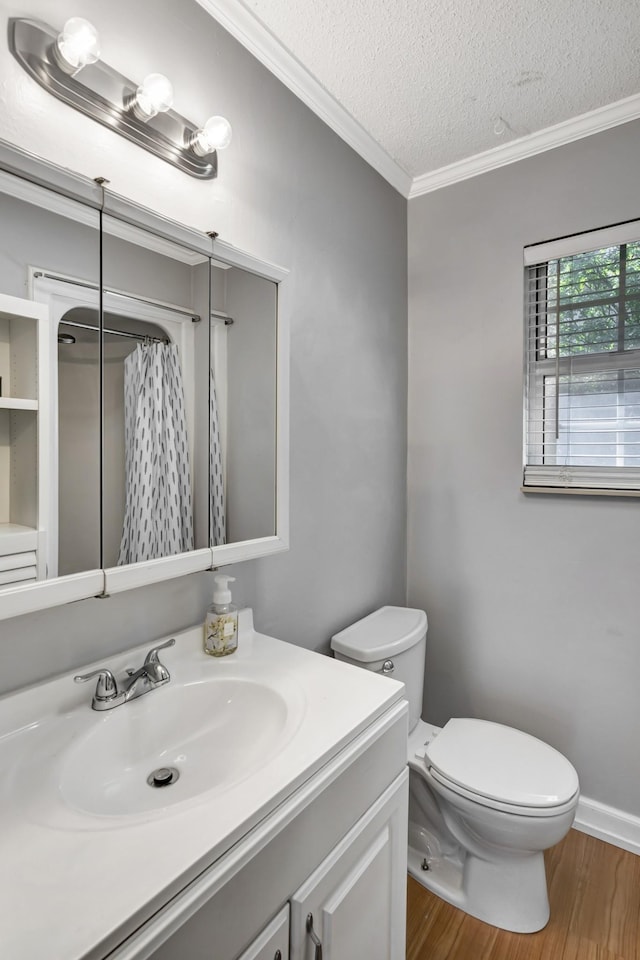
[{"xmin": 102, "ymin": 215, "xmax": 209, "ymax": 569}]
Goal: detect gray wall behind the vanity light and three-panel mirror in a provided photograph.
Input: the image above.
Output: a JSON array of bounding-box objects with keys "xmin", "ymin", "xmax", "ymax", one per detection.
[{"xmin": 0, "ymin": 0, "xmax": 407, "ymax": 690}]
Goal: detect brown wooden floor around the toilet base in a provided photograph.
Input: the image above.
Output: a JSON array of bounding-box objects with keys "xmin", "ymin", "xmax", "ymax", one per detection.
[{"xmin": 407, "ymin": 830, "xmax": 640, "ymax": 960}]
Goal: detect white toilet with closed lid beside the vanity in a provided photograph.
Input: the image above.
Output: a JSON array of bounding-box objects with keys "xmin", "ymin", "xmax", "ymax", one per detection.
[{"xmin": 331, "ymin": 607, "xmax": 579, "ymax": 933}]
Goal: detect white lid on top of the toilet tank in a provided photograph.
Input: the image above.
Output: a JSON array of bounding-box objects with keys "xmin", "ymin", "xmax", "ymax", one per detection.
[{"xmin": 331, "ymin": 607, "xmax": 427, "ymax": 663}]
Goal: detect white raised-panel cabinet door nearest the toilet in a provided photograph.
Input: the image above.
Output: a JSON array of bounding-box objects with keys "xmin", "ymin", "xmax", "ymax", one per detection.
[{"xmin": 291, "ymin": 770, "xmax": 408, "ymax": 960}]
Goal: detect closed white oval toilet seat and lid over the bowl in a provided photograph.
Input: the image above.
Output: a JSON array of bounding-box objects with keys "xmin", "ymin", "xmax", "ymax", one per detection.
[{"xmin": 425, "ymin": 718, "xmax": 579, "ymax": 816}]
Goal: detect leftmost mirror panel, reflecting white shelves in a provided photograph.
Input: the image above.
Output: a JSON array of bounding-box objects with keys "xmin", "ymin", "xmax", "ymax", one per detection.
[{"xmin": 0, "ymin": 172, "xmax": 100, "ymax": 590}]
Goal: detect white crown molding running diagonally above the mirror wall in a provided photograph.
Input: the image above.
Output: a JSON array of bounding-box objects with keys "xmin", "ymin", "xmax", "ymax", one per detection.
[{"xmin": 198, "ymin": 0, "xmax": 412, "ymax": 197}]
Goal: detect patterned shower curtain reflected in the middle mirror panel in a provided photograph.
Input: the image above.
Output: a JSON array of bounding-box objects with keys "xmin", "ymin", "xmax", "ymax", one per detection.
[{"xmin": 118, "ymin": 343, "xmax": 193, "ymax": 565}]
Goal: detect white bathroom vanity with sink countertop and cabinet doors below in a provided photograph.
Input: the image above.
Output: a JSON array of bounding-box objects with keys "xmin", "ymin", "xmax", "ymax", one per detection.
[{"xmin": 0, "ymin": 624, "xmax": 408, "ymax": 960}]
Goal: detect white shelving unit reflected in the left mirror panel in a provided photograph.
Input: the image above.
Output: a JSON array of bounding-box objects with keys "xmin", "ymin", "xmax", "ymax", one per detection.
[{"xmin": 0, "ymin": 294, "xmax": 48, "ymax": 590}]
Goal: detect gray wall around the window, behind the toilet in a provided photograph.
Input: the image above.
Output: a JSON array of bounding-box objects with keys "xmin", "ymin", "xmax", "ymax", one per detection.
[{"xmin": 408, "ymin": 116, "xmax": 640, "ymax": 814}]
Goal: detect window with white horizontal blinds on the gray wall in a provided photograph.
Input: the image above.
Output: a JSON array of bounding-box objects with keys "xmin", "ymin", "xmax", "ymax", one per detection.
[{"xmin": 524, "ymin": 222, "xmax": 640, "ymax": 491}]
